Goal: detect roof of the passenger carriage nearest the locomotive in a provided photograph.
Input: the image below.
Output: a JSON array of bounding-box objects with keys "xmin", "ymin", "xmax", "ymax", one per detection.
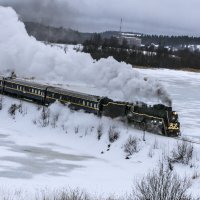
[{"xmin": 48, "ymin": 87, "xmax": 101, "ymax": 101}]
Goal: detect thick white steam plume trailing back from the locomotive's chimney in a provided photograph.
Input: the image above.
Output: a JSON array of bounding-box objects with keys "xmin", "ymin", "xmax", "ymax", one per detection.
[{"xmin": 0, "ymin": 7, "xmax": 171, "ymax": 105}]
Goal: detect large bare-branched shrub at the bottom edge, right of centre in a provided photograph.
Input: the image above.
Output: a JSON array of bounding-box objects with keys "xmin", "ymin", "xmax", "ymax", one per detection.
[{"xmin": 130, "ymin": 163, "xmax": 192, "ymax": 200}]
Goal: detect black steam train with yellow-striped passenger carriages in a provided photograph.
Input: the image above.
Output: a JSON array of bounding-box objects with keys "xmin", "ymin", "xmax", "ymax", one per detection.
[{"xmin": 0, "ymin": 76, "xmax": 180, "ymax": 137}]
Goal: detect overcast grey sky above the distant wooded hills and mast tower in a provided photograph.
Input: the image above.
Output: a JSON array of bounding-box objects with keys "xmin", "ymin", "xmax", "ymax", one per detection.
[{"xmin": 0, "ymin": 0, "xmax": 200, "ymax": 36}]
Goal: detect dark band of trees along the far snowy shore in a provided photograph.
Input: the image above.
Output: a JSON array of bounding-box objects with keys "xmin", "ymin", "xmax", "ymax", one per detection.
[{"xmin": 83, "ymin": 34, "xmax": 200, "ymax": 69}]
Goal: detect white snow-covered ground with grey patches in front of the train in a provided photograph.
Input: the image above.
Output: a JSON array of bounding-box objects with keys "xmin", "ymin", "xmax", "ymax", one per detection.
[{"xmin": 0, "ymin": 94, "xmax": 200, "ymax": 199}]
